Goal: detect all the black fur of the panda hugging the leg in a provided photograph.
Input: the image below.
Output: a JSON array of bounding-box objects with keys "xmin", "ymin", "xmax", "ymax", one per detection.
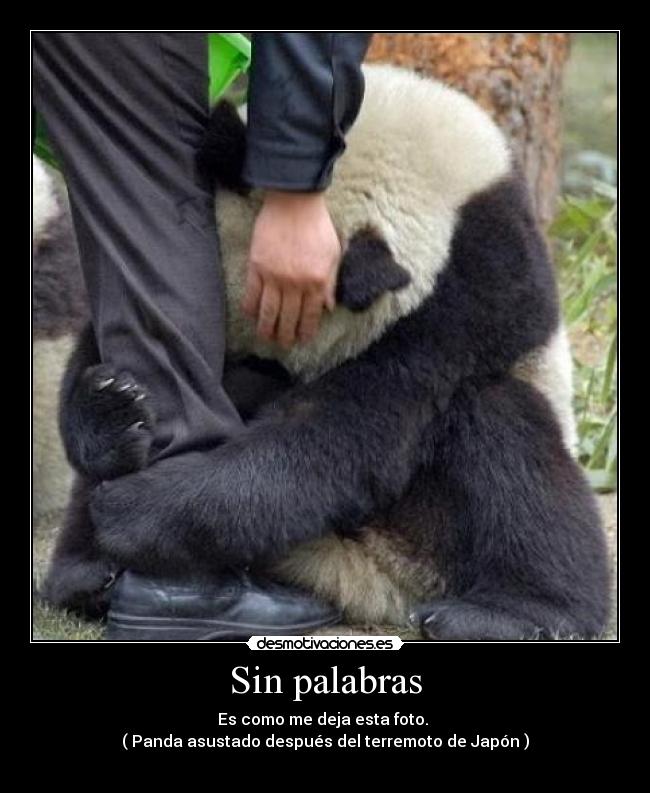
[{"xmin": 40, "ymin": 66, "xmax": 608, "ymax": 640}]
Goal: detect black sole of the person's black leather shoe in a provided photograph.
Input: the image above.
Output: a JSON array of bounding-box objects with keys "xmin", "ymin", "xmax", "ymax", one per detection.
[{"xmin": 104, "ymin": 614, "xmax": 342, "ymax": 642}]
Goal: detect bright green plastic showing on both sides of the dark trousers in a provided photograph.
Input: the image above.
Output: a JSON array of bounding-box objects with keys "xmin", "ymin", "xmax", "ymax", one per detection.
[{"xmin": 33, "ymin": 33, "xmax": 251, "ymax": 168}]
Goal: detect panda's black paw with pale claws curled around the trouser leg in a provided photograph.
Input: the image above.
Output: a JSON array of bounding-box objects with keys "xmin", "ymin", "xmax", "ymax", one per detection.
[{"xmin": 60, "ymin": 330, "xmax": 155, "ymax": 481}]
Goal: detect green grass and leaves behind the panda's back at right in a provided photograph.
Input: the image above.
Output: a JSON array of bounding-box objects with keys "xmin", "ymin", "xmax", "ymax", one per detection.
[{"xmin": 550, "ymin": 183, "xmax": 618, "ymax": 492}]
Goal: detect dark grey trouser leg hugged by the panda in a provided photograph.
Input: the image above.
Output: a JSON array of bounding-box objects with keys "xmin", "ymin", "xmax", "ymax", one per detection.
[{"xmin": 34, "ymin": 33, "xmax": 241, "ymax": 459}]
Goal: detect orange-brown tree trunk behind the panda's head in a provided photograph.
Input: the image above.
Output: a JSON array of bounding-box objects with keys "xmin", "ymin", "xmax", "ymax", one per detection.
[{"xmin": 367, "ymin": 33, "xmax": 569, "ymax": 227}]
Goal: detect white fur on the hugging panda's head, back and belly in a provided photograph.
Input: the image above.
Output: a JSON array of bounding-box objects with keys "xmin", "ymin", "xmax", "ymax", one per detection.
[{"xmin": 211, "ymin": 66, "xmax": 576, "ymax": 624}]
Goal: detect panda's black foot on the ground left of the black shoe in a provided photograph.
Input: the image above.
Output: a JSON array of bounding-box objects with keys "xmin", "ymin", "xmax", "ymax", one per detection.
[{"xmin": 39, "ymin": 478, "xmax": 119, "ymax": 618}]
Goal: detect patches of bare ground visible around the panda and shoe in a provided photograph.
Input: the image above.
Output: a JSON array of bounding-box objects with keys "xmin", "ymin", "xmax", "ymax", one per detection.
[{"xmin": 33, "ymin": 493, "xmax": 617, "ymax": 641}]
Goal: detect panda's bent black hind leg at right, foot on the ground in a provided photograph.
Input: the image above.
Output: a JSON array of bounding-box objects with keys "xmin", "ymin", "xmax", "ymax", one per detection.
[{"xmin": 416, "ymin": 379, "xmax": 608, "ymax": 641}]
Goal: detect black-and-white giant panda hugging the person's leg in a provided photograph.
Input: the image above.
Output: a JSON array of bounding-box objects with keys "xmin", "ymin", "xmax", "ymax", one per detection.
[{"xmin": 40, "ymin": 66, "xmax": 608, "ymax": 640}]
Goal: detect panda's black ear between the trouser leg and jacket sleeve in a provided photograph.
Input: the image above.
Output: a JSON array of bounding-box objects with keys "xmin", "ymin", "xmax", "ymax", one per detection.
[{"xmin": 196, "ymin": 99, "xmax": 250, "ymax": 195}]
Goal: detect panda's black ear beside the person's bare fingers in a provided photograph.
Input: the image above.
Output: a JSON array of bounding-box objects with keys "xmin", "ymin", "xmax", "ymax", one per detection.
[{"xmin": 336, "ymin": 228, "xmax": 411, "ymax": 311}]
